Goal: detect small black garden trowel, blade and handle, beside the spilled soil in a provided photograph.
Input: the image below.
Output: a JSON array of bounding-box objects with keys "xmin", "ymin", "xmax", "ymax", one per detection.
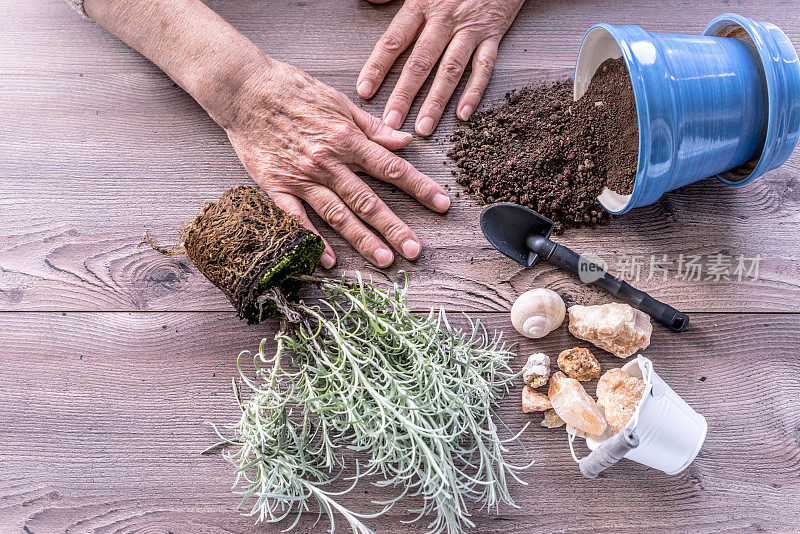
[{"xmin": 481, "ymin": 202, "xmax": 689, "ymax": 332}]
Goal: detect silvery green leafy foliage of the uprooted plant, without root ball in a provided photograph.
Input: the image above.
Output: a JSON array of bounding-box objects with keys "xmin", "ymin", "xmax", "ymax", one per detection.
[{"xmin": 209, "ymin": 275, "xmax": 527, "ymax": 533}]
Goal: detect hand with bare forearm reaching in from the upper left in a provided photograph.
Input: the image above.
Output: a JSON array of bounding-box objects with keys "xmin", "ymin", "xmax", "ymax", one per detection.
[{"xmin": 84, "ymin": 0, "xmax": 450, "ymax": 268}]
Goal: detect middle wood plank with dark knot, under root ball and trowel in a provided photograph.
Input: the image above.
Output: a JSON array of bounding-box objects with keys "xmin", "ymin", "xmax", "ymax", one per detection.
[{"xmin": 0, "ymin": 70, "xmax": 800, "ymax": 312}]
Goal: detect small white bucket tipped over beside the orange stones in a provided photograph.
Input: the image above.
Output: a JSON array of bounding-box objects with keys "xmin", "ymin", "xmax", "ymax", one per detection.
[{"xmin": 586, "ymin": 354, "xmax": 708, "ymax": 475}]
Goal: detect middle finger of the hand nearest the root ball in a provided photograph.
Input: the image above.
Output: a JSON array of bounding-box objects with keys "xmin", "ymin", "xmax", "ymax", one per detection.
[{"xmin": 331, "ymin": 165, "xmax": 422, "ymax": 260}]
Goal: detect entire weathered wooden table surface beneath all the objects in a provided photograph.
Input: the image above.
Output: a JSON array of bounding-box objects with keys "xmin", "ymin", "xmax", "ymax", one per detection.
[{"xmin": 0, "ymin": 0, "xmax": 800, "ymax": 534}]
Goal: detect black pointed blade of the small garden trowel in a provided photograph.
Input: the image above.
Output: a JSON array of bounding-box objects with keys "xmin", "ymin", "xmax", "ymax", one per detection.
[{"xmin": 481, "ymin": 202, "xmax": 554, "ymax": 267}]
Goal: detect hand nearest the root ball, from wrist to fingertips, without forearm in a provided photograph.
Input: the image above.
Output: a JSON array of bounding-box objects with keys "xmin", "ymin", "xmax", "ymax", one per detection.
[{"xmin": 221, "ymin": 58, "xmax": 450, "ymax": 268}]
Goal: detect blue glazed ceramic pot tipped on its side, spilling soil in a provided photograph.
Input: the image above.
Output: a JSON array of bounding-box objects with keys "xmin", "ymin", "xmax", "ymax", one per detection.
[{"xmin": 574, "ymin": 14, "xmax": 800, "ymax": 214}]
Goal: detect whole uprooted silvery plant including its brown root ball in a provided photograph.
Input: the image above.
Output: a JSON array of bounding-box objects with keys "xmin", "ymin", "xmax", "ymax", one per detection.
[{"xmin": 153, "ymin": 186, "xmax": 527, "ymax": 533}]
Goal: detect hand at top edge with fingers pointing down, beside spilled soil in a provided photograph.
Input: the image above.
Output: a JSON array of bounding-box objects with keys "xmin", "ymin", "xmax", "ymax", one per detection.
[{"xmin": 356, "ymin": 0, "xmax": 524, "ymax": 135}]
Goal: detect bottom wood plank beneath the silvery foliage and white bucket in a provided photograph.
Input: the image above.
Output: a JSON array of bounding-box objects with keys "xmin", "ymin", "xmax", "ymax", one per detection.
[{"xmin": 0, "ymin": 313, "xmax": 800, "ymax": 533}]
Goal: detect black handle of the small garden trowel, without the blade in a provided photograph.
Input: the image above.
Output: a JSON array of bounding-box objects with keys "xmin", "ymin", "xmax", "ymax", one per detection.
[{"xmin": 528, "ymin": 236, "xmax": 689, "ymax": 332}]
